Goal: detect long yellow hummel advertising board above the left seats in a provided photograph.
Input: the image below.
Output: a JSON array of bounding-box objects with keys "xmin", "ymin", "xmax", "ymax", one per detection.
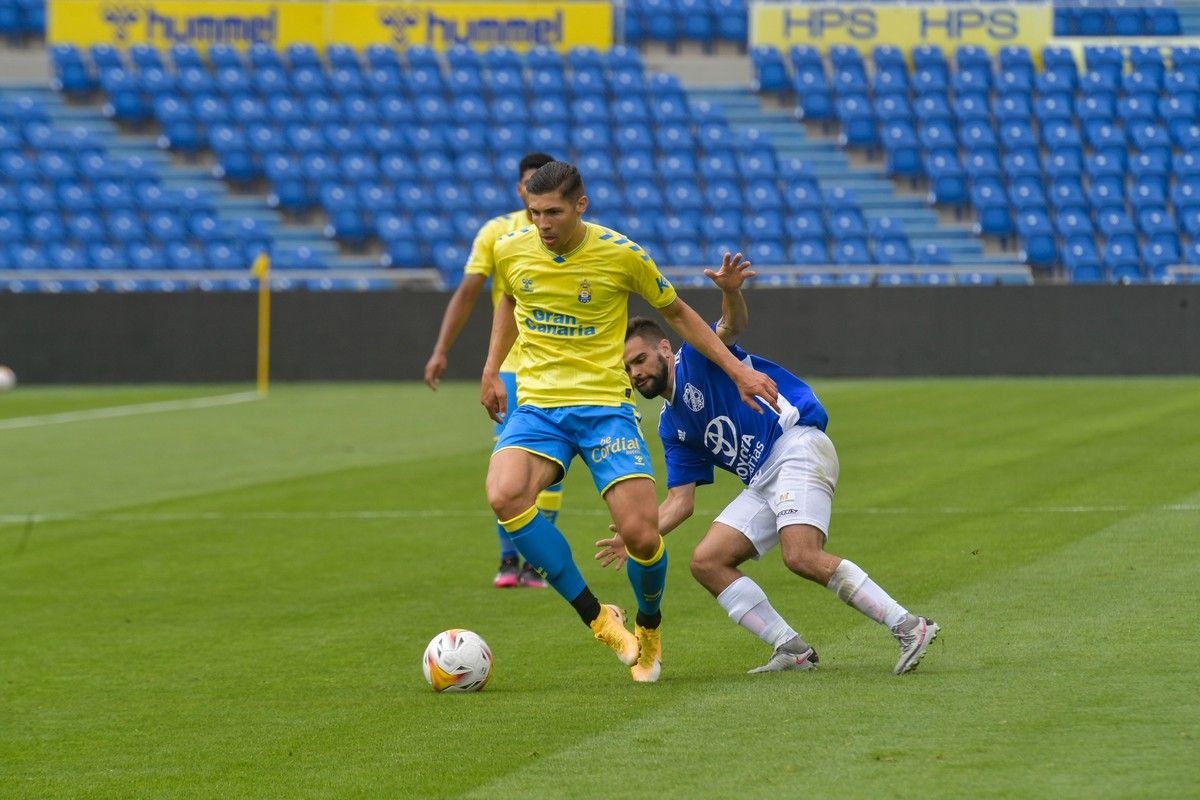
[{"xmin": 47, "ymin": 0, "xmax": 613, "ymax": 50}]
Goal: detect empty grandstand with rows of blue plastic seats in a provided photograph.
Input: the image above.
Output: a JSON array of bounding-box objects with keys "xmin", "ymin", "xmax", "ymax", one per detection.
[{"xmin": 0, "ymin": 0, "xmax": 1200, "ymax": 291}]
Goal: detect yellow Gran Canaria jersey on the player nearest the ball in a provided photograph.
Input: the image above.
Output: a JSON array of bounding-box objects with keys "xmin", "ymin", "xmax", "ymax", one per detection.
[{"xmin": 496, "ymin": 223, "xmax": 676, "ymax": 408}]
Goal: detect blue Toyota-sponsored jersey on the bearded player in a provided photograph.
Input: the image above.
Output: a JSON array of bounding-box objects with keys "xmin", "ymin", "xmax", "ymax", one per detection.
[{"xmin": 659, "ymin": 344, "xmax": 829, "ymax": 487}]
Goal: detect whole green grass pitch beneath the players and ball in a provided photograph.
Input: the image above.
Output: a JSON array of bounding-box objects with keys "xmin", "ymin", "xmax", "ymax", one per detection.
[{"xmin": 0, "ymin": 379, "xmax": 1200, "ymax": 799}]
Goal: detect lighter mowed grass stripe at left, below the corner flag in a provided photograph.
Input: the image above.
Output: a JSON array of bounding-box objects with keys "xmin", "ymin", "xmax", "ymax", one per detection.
[{"xmin": 0, "ymin": 384, "xmax": 491, "ymax": 515}]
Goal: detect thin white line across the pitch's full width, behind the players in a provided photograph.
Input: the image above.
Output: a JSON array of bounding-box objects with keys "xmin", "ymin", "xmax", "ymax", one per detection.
[{"xmin": 0, "ymin": 503, "xmax": 1200, "ymax": 525}]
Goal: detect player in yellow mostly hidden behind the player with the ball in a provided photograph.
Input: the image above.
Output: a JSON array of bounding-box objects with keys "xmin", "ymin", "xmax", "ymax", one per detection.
[{"xmin": 425, "ymin": 152, "xmax": 563, "ymax": 589}]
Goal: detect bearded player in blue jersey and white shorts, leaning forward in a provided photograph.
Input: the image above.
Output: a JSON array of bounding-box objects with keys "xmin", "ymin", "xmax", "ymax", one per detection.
[{"xmin": 596, "ymin": 253, "xmax": 938, "ymax": 675}]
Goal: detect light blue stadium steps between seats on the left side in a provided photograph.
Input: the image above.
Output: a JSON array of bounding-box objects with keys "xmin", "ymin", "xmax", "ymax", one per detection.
[{"xmin": 23, "ymin": 86, "xmax": 350, "ymax": 269}]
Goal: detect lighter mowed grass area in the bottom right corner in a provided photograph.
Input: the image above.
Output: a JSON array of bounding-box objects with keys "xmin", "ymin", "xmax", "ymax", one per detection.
[{"xmin": 458, "ymin": 495, "xmax": 1200, "ymax": 799}]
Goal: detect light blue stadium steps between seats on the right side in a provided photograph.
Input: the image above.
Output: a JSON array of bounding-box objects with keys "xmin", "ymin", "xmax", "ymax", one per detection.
[{"xmin": 688, "ymin": 88, "xmax": 1013, "ymax": 265}]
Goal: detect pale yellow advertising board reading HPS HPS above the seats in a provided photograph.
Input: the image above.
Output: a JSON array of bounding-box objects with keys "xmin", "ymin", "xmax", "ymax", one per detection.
[{"xmin": 750, "ymin": 2, "xmax": 1054, "ymax": 52}]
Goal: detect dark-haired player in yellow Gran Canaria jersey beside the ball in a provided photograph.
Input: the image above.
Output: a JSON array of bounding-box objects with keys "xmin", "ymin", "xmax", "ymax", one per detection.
[{"xmin": 480, "ymin": 161, "xmax": 778, "ymax": 682}]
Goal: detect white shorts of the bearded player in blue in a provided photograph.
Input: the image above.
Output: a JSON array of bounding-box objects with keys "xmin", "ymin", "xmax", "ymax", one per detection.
[{"xmin": 716, "ymin": 427, "xmax": 838, "ymax": 559}]
